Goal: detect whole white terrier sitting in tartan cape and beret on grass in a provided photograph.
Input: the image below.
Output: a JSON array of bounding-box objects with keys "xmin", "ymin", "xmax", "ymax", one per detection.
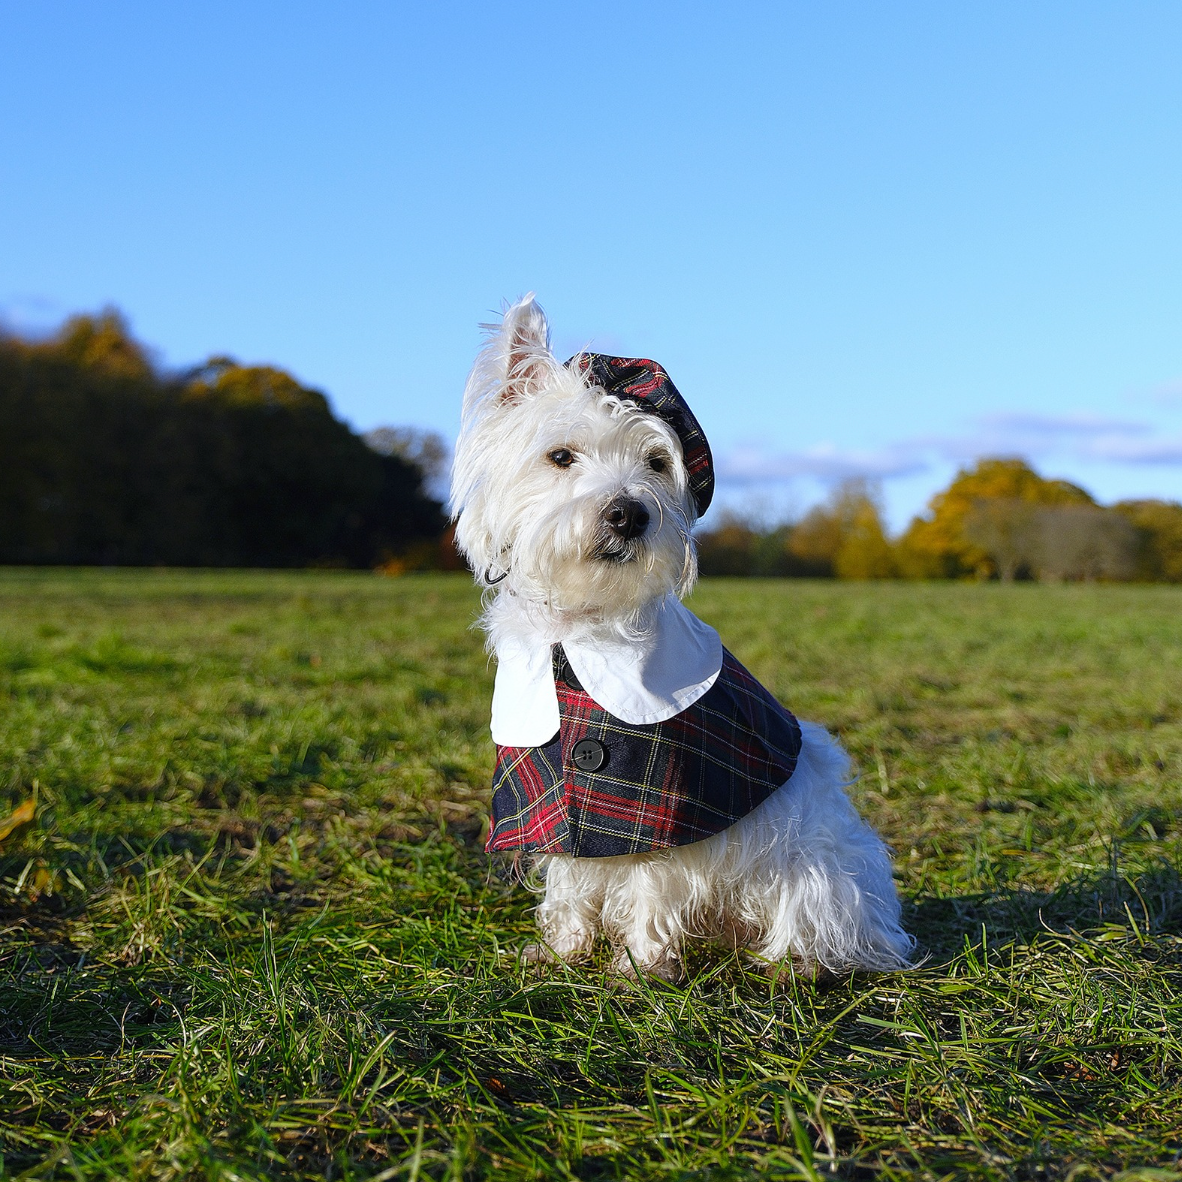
[{"xmin": 450, "ymin": 294, "xmax": 914, "ymax": 982}]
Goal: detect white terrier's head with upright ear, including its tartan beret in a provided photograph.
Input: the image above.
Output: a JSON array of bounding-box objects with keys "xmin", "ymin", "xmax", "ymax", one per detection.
[{"xmin": 452, "ymin": 296, "xmax": 709, "ymax": 618}]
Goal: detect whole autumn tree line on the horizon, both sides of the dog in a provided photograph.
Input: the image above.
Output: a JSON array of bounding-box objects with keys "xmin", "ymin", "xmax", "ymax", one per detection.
[{"xmin": 0, "ymin": 311, "xmax": 1182, "ymax": 582}]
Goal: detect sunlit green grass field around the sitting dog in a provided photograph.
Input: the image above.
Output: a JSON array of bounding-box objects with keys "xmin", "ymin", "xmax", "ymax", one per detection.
[{"xmin": 0, "ymin": 570, "xmax": 1182, "ymax": 1180}]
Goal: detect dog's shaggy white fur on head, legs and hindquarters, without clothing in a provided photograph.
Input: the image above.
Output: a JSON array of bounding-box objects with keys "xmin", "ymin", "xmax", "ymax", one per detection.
[{"xmin": 452, "ymin": 296, "xmax": 913, "ymax": 980}]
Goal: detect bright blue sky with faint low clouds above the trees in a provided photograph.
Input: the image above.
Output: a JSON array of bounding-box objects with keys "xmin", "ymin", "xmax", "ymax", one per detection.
[{"xmin": 0, "ymin": 0, "xmax": 1182, "ymax": 527}]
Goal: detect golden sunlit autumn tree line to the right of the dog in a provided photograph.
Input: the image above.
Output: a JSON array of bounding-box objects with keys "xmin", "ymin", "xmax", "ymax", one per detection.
[{"xmin": 699, "ymin": 459, "xmax": 1182, "ymax": 583}]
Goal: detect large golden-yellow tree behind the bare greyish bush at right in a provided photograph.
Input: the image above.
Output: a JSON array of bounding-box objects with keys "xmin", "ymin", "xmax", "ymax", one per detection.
[{"xmin": 897, "ymin": 459, "xmax": 1096, "ymax": 578}]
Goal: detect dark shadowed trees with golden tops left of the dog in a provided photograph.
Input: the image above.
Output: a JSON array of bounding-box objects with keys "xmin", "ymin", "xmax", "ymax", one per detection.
[{"xmin": 0, "ymin": 312, "xmax": 448, "ymax": 566}]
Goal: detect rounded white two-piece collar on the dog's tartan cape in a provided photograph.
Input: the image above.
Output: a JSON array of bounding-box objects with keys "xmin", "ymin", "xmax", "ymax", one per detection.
[{"xmin": 492, "ymin": 595, "xmax": 722, "ymax": 747}]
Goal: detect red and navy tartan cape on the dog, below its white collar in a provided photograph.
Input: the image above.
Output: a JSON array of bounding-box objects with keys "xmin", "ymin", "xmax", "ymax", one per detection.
[{"xmin": 486, "ymin": 644, "xmax": 800, "ymax": 858}]
